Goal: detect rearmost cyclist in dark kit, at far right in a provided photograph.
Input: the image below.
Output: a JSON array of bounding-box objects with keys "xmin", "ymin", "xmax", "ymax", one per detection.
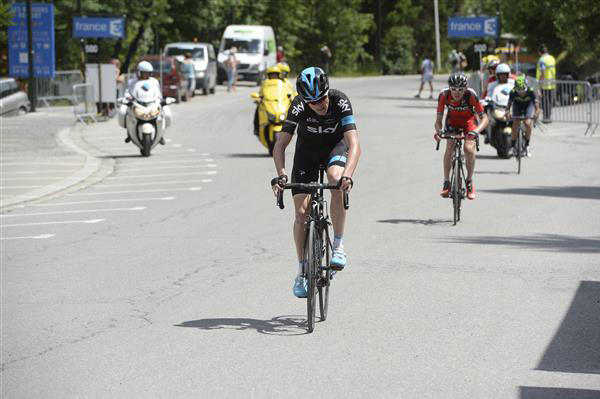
[{"xmin": 506, "ymin": 75, "xmax": 541, "ymax": 157}]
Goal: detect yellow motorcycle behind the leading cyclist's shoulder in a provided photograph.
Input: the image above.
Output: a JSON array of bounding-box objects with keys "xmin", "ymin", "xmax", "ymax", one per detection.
[{"xmin": 250, "ymin": 79, "xmax": 292, "ymax": 156}]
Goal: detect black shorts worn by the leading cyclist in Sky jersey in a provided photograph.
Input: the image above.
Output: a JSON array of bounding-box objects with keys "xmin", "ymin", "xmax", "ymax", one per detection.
[{"xmin": 292, "ymin": 140, "xmax": 348, "ymax": 195}]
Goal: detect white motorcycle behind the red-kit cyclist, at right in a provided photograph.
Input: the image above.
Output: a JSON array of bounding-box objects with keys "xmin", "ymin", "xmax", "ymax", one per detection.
[{"xmin": 482, "ymin": 83, "xmax": 513, "ymax": 159}]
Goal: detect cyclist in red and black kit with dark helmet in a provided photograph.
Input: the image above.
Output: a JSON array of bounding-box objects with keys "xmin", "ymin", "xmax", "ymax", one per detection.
[{"xmin": 433, "ymin": 73, "xmax": 488, "ymax": 200}]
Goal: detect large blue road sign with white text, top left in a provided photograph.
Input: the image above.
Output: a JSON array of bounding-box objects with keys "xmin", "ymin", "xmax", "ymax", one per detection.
[{"xmin": 8, "ymin": 3, "xmax": 56, "ymax": 78}]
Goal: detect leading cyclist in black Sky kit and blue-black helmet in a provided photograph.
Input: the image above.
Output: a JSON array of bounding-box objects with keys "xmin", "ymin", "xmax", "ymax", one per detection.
[{"xmin": 273, "ymin": 67, "xmax": 360, "ymax": 298}]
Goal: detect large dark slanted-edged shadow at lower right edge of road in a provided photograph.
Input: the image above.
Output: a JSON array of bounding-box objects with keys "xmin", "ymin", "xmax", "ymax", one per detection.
[{"xmin": 537, "ymin": 281, "xmax": 600, "ymax": 376}]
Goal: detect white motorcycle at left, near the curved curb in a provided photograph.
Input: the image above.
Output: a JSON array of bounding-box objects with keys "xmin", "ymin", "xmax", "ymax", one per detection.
[{"xmin": 119, "ymin": 80, "xmax": 176, "ymax": 157}]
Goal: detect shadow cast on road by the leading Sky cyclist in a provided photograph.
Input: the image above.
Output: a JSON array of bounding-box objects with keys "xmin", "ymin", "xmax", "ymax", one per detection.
[{"xmin": 175, "ymin": 316, "xmax": 308, "ymax": 336}]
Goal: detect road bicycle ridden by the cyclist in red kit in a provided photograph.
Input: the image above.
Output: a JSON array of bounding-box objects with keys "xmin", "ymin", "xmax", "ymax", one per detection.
[{"xmin": 435, "ymin": 128, "xmax": 479, "ymax": 226}]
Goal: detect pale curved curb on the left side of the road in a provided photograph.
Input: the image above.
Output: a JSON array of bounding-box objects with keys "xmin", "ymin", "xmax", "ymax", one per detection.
[{"xmin": 0, "ymin": 125, "xmax": 115, "ymax": 212}]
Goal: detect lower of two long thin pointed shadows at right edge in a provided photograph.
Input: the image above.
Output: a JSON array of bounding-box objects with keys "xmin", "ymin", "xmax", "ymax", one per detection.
[{"xmin": 443, "ymin": 234, "xmax": 600, "ymax": 254}]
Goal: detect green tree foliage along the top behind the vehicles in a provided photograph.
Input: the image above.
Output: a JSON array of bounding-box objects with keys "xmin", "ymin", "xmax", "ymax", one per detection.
[{"xmin": 0, "ymin": 0, "xmax": 600, "ymax": 73}]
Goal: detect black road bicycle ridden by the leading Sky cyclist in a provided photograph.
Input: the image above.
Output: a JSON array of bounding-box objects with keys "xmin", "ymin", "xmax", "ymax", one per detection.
[{"xmin": 277, "ymin": 166, "xmax": 348, "ymax": 333}]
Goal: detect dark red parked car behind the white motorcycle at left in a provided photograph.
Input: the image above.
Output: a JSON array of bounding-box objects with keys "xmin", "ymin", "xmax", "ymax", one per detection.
[{"xmin": 140, "ymin": 55, "xmax": 192, "ymax": 102}]
